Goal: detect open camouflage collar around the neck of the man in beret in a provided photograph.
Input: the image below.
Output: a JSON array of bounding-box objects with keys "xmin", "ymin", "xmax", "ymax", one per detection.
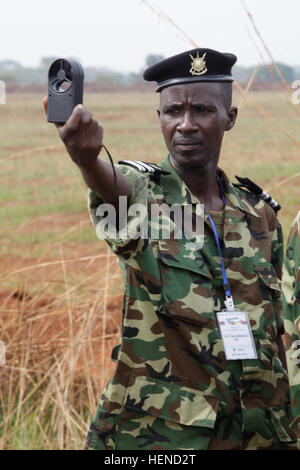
[{"xmin": 159, "ymin": 155, "xmax": 260, "ymax": 218}]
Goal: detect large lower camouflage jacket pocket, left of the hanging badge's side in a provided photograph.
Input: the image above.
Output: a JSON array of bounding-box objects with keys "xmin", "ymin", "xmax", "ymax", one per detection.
[{"xmin": 116, "ymin": 376, "xmax": 219, "ymax": 450}]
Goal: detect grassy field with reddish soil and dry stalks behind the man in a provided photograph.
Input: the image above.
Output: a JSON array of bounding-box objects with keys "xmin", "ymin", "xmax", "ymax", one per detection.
[{"xmin": 0, "ymin": 91, "xmax": 300, "ymax": 449}]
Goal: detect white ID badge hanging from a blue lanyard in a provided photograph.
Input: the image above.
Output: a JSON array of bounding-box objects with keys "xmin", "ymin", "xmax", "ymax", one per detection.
[{"xmin": 217, "ymin": 310, "xmax": 257, "ymax": 360}]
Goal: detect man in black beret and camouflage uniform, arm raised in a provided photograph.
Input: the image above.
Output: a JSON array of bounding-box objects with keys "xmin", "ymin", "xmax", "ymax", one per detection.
[{"xmin": 44, "ymin": 49, "xmax": 295, "ymax": 450}]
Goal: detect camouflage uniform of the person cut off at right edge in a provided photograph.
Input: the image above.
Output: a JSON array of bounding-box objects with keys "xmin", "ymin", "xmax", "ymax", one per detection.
[{"xmin": 282, "ymin": 212, "xmax": 300, "ymax": 442}]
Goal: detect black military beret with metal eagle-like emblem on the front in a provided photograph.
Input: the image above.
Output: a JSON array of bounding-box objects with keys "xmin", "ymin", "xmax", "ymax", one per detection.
[{"xmin": 144, "ymin": 48, "xmax": 237, "ymax": 91}]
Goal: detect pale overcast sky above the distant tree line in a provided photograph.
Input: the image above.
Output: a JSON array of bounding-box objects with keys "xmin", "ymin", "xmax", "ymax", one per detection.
[{"xmin": 0, "ymin": 0, "xmax": 300, "ymax": 73}]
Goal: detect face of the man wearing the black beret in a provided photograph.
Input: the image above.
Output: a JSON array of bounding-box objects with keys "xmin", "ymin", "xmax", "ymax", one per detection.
[{"xmin": 158, "ymin": 82, "xmax": 237, "ymax": 170}]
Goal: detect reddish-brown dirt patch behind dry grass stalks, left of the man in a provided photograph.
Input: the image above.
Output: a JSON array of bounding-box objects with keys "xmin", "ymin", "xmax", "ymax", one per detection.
[{"xmin": 0, "ymin": 213, "xmax": 123, "ymax": 381}]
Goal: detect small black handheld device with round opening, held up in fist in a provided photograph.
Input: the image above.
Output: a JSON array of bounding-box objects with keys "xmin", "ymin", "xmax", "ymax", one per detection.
[{"xmin": 47, "ymin": 59, "xmax": 84, "ymax": 124}]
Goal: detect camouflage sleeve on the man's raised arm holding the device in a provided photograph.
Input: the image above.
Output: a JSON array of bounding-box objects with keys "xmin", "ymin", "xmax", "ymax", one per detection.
[{"xmin": 88, "ymin": 165, "xmax": 148, "ymax": 259}]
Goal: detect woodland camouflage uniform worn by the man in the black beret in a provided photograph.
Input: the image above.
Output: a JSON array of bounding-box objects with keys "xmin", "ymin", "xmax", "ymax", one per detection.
[{"xmin": 88, "ymin": 158, "xmax": 295, "ymax": 450}]
